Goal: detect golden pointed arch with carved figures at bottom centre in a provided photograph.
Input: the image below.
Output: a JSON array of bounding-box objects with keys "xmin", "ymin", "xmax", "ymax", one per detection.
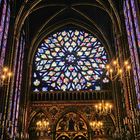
[{"xmin": 55, "ymin": 112, "xmax": 88, "ymax": 139}]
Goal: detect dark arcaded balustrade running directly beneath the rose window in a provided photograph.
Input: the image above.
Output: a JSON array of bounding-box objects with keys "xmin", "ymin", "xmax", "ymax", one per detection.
[{"xmin": 31, "ymin": 90, "xmax": 113, "ymax": 101}]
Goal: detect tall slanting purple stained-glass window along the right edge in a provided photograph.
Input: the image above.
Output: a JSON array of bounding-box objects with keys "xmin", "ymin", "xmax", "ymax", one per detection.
[{"xmin": 124, "ymin": 0, "xmax": 140, "ymax": 108}]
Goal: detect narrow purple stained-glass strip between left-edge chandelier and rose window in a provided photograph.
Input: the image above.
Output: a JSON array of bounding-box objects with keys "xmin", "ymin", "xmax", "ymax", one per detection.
[{"xmin": 9, "ymin": 33, "xmax": 25, "ymax": 134}]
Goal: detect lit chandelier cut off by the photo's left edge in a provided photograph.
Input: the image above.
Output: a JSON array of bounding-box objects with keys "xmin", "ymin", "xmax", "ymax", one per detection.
[{"xmin": 0, "ymin": 67, "xmax": 12, "ymax": 86}]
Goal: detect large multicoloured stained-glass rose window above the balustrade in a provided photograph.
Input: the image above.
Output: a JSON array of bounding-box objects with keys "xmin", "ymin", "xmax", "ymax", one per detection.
[{"xmin": 33, "ymin": 29, "xmax": 107, "ymax": 91}]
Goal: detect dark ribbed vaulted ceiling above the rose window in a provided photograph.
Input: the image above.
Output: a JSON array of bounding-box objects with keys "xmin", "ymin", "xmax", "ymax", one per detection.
[{"xmin": 17, "ymin": 0, "xmax": 120, "ymax": 55}]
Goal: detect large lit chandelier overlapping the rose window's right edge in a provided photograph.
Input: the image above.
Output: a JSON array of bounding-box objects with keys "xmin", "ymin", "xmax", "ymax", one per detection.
[{"xmin": 106, "ymin": 59, "xmax": 131, "ymax": 81}]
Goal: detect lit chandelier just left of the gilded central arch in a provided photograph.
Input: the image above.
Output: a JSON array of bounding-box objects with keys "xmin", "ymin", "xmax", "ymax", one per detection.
[{"xmin": 36, "ymin": 118, "xmax": 49, "ymax": 131}]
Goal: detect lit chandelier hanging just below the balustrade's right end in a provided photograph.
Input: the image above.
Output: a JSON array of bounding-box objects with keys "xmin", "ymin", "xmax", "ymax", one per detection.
[{"xmin": 95, "ymin": 100, "xmax": 112, "ymax": 115}]
